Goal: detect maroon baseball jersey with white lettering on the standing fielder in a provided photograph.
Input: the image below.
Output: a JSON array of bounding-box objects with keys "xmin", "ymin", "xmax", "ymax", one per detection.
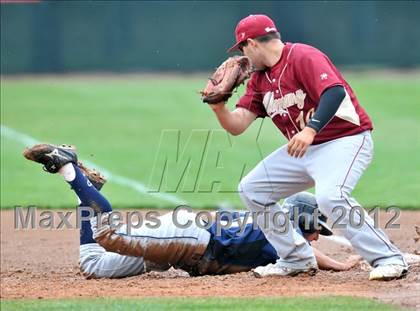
[{"xmin": 236, "ymin": 43, "xmax": 373, "ymax": 144}]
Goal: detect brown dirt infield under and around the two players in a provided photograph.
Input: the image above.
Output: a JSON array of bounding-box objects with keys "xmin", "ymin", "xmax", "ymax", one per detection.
[{"xmin": 1, "ymin": 211, "xmax": 420, "ymax": 309}]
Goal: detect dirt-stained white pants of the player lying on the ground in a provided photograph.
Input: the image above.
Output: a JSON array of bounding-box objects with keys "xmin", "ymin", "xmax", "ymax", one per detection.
[{"xmin": 79, "ymin": 211, "xmax": 210, "ymax": 278}]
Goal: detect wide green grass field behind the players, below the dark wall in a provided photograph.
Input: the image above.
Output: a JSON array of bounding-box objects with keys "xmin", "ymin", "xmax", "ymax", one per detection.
[{"xmin": 1, "ymin": 75, "xmax": 420, "ymax": 208}]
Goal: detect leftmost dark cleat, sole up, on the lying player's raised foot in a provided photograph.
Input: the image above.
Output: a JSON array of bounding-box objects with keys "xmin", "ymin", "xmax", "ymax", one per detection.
[{"xmin": 23, "ymin": 144, "xmax": 77, "ymax": 173}]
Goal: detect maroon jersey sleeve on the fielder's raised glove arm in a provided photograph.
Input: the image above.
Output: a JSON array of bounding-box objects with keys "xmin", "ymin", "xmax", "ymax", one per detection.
[{"xmin": 236, "ymin": 73, "xmax": 267, "ymax": 118}]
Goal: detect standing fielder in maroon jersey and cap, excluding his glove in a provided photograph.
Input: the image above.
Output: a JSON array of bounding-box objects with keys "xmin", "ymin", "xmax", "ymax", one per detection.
[{"xmin": 210, "ymin": 15, "xmax": 408, "ymax": 280}]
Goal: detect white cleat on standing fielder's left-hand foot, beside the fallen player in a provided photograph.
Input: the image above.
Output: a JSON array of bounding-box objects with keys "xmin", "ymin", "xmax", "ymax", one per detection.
[{"xmin": 253, "ymin": 262, "xmax": 318, "ymax": 278}]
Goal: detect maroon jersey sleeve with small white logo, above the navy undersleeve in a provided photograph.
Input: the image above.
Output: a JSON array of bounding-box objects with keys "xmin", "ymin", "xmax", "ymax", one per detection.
[{"xmin": 295, "ymin": 45, "xmax": 343, "ymax": 103}]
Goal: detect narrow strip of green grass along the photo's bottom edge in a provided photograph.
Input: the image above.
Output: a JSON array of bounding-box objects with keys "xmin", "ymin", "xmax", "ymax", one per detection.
[{"xmin": 1, "ymin": 297, "xmax": 400, "ymax": 311}]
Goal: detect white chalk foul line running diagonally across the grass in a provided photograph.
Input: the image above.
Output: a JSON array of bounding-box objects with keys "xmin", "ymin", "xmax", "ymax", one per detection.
[{"xmin": 1, "ymin": 124, "xmax": 186, "ymax": 205}]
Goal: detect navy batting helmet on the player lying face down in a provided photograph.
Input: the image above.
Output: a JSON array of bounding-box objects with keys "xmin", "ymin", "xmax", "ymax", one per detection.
[{"xmin": 283, "ymin": 192, "xmax": 333, "ymax": 235}]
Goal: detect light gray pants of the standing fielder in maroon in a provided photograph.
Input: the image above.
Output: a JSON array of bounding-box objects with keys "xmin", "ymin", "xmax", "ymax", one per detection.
[{"xmin": 239, "ymin": 131, "xmax": 405, "ymax": 267}]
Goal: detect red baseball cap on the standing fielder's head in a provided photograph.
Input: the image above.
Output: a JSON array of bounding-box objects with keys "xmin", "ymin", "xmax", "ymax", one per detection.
[{"xmin": 228, "ymin": 15, "xmax": 277, "ymax": 52}]
